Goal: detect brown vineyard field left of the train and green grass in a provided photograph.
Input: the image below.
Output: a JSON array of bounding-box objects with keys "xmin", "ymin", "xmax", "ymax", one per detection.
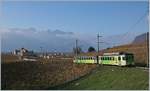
[{"xmin": 1, "ymin": 58, "xmax": 96, "ymax": 89}]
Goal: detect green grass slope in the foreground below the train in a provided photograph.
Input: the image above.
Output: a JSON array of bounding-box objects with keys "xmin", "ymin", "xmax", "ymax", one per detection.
[{"xmin": 49, "ymin": 66, "xmax": 149, "ymax": 90}]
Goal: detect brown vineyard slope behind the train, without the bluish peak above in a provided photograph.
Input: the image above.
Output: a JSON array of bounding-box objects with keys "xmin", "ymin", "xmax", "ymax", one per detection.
[{"xmin": 105, "ymin": 44, "xmax": 148, "ymax": 66}]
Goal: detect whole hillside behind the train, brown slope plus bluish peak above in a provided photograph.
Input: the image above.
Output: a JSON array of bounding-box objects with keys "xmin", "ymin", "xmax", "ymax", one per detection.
[{"xmin": 105, "ymin": 33, "xmax": 148, "ymax": 66}]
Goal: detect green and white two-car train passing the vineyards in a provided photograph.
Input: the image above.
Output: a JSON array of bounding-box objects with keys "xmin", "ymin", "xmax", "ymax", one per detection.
[{"xmin": 73, "ymin": 52, "xmax": 134, "ymax": 66}]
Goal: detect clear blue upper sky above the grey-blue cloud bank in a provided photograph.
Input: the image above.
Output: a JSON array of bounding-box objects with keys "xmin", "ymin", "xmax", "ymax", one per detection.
[{"xmin": 0, "ymin": 1, "xmax": 148, "ymax": 36}]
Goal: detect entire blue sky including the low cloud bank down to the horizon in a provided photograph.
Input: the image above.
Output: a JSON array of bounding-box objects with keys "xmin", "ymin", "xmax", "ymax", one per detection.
[{"xmin": 0, "ymin": 1, "xmax": 148, "ymax": 51}]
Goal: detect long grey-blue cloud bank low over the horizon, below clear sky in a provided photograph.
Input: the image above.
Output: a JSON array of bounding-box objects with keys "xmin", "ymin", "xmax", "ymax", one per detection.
[{"xmin": 0, "ymin": 28, "xmax": 138, "ymax": 51}]
